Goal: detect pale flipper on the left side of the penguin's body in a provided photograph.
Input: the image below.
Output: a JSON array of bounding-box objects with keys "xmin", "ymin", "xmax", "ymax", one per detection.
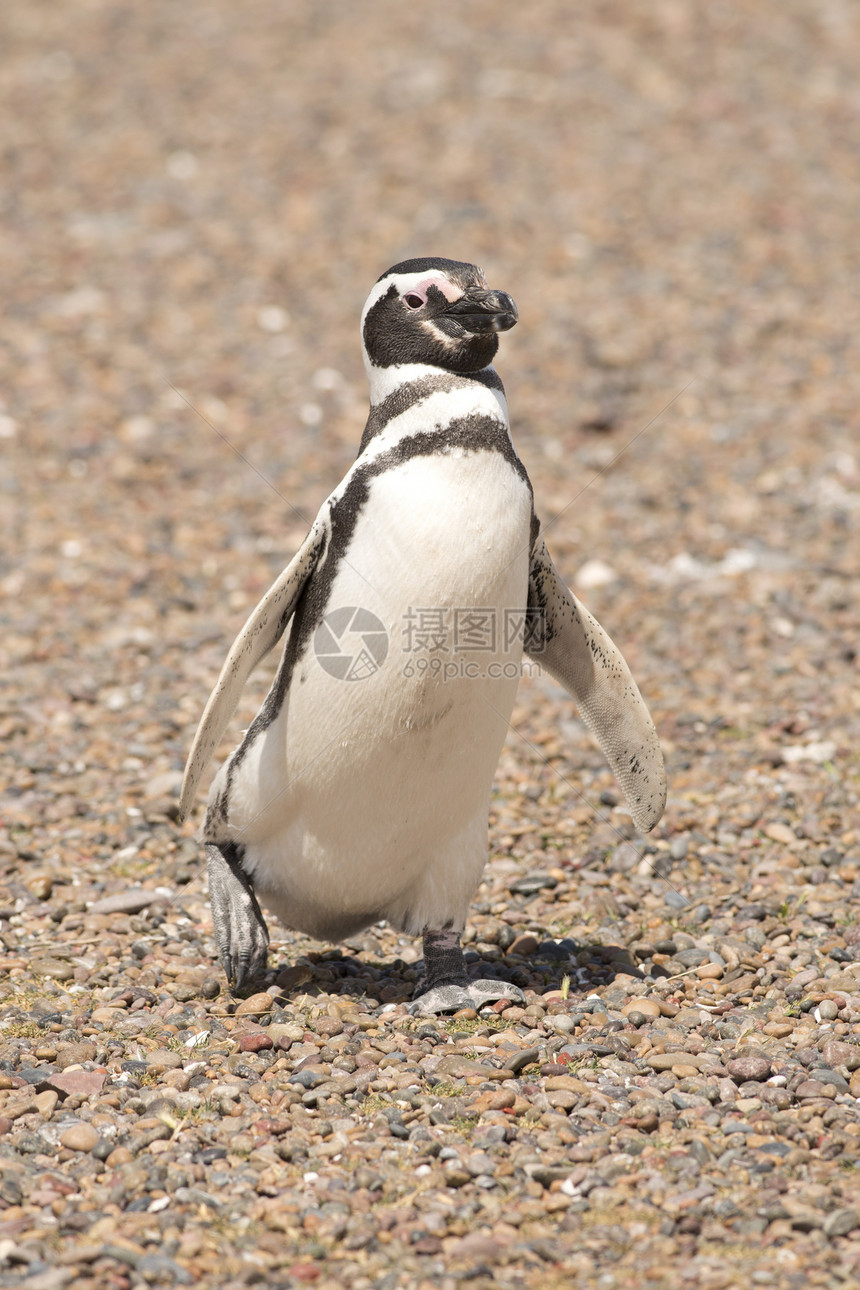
[{"xmin": 179, "ymin": 512, "xmax": 329, "ymax": 819}]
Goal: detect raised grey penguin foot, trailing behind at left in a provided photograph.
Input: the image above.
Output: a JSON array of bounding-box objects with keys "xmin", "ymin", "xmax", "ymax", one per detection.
[{"xmin": 206, "ymin": 842, "xmax": 268, "ymax": 989}]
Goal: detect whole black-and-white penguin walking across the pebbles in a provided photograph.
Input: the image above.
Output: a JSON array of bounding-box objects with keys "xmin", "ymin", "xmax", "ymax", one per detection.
[{"xmin": 181, "ymin": 258, "xmax": 665, "ymax": 1014}]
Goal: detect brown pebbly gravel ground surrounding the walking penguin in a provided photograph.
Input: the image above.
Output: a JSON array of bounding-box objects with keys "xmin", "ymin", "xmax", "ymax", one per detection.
[{"xmin": 0, "ymin": 0, "xmax": 860, "ymax": 1290}]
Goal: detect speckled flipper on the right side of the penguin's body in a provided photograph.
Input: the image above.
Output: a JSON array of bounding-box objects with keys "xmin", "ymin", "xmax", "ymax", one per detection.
[{"xmin": 525, "ymin": 538, "xmax": 667, "ymax": 833}]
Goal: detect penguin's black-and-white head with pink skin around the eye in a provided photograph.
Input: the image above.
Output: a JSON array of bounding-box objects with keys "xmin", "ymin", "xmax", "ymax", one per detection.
[{"xmin": 361, "ymin": 257, "xmax": 517, "ymax": 375}]
